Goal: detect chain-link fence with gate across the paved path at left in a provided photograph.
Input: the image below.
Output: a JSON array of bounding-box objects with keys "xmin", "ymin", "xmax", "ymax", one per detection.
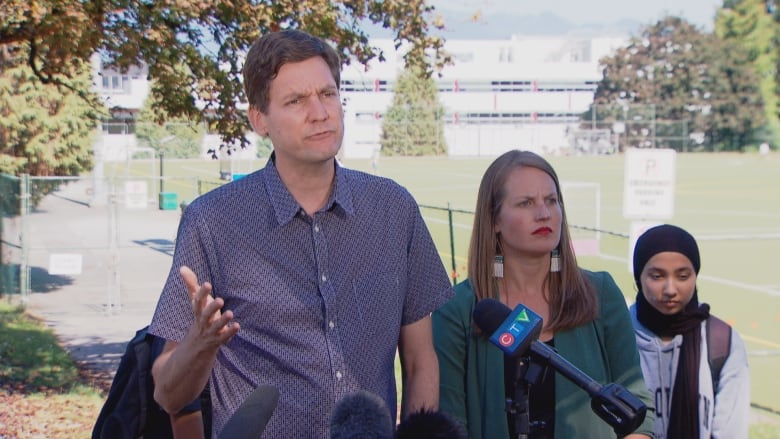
[{"xmin": 0, "ymin": 174, "xmax": 219, "ymax": 300}]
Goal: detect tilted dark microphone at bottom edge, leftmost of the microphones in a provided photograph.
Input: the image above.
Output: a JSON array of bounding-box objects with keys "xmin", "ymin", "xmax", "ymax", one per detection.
[{"xmin": 219, "ymin": 384, "xmax": 279, "ymax": 439}]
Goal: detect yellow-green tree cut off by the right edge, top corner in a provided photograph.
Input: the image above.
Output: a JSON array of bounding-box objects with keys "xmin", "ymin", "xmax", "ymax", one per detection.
[{"xmin": 715, "ymin": 0, "xmax": 780, "ymax": 143}]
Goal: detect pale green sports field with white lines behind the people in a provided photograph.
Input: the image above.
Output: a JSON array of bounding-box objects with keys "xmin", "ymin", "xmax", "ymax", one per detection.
[{"xmin": 106, "ymin": 154, "xmax": 780, "ymax": 422}]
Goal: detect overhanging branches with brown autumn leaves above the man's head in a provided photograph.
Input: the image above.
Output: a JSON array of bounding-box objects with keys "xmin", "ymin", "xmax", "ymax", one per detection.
[{"xmin": 0, "ymin": 0, "xmax": 448, "ymax": 150}]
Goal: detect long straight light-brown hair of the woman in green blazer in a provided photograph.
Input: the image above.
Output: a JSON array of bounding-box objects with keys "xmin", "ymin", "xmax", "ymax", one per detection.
[{"xmin": 468, "ymin": 150, "xmax": 598, "ymax": 331}]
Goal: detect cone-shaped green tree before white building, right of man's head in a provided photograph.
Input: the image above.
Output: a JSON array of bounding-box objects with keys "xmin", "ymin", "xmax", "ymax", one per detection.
[{"xmin": 380, "ymin": 67, "xmax": 447, "ymax": 156}]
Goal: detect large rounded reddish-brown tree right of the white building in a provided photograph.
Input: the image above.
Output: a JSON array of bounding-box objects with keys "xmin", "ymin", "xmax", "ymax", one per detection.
[{"xmin": 584, "ymin": 16, "xmax": 764, "ymax": 150}]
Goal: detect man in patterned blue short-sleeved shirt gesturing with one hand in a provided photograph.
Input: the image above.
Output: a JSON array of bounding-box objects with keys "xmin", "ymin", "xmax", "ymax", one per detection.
[{"xmin": 150, "ymin": 31, "xmax": 451, "ymax": 438}]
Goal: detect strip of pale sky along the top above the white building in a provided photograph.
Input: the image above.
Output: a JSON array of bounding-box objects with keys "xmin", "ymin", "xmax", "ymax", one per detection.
[{"xmin": 429, "ymin": 0, "xmax": 723, "ymax": 30}]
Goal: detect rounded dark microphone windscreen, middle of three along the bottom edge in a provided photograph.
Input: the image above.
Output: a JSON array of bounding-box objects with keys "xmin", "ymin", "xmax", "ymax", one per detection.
[{"xmin": 330, "ymin": 390, "xmax": 395, "ymax": 439}]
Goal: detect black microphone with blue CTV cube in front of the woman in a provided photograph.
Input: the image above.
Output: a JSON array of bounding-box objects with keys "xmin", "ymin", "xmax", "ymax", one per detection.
[{"xmin": 473, "ymin": 299, "xmax": 647, "ymax": 436}]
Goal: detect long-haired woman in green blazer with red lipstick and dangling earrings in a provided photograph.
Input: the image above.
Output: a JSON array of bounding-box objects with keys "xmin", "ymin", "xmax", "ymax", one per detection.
[{"xmin": 433, "ymin": 151, "xmax": 653, "ymax": 439}]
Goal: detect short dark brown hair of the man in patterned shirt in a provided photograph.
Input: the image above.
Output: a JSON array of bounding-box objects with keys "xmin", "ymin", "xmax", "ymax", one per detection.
[{"xmin": 244, "ymin": 30, "xmax": 341, "ymax": 113}]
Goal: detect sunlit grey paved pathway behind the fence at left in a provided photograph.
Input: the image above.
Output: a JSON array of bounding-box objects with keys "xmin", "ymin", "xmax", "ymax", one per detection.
[{"xmin": 22, "ymin": 182, "xmax": 180, "ymax": 372}]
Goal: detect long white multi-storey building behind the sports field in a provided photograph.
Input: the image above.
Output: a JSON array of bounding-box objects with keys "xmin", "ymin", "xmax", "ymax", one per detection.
[{"xmin": 96, "ymin": 36, "xmax": 628, "ymax": 159}]
